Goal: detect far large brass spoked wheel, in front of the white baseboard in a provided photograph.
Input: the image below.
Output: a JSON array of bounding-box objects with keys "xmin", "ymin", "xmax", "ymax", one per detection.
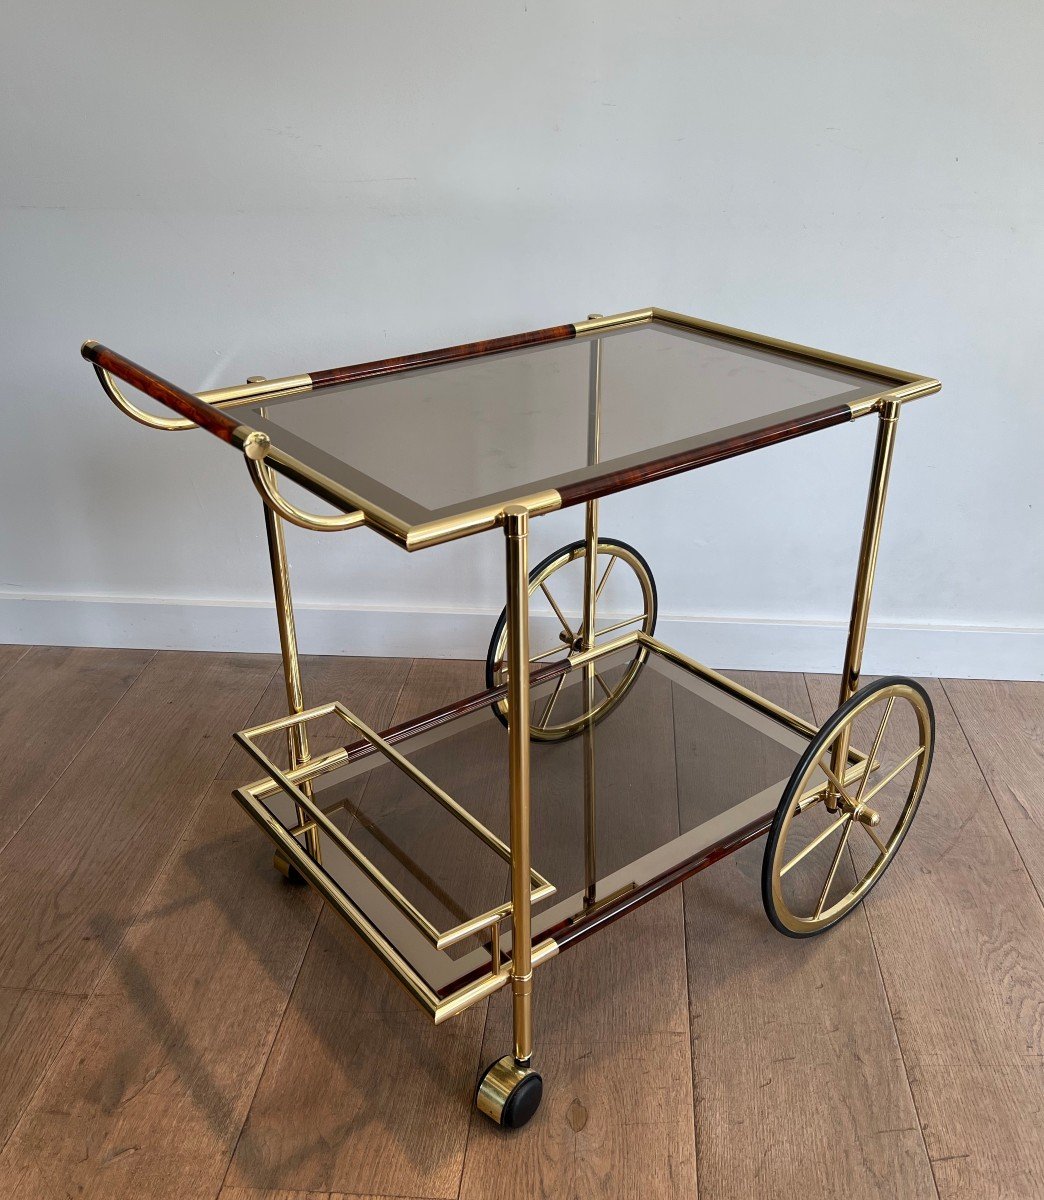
[{"xmin": 486, "ymin": 538, "xmax": 658, "ymax": 742}]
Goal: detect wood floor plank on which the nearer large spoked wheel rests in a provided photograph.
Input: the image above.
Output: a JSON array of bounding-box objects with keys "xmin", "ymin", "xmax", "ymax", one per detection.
[{"xmin": 684, "ymin": 673, "xmax": 936, "ymax": 1200}]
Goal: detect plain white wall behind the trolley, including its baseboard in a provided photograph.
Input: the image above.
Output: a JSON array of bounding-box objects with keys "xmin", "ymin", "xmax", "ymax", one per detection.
[{"xmin": 0, "ymin": 0, "xmax": 1044, "ymax": 678}]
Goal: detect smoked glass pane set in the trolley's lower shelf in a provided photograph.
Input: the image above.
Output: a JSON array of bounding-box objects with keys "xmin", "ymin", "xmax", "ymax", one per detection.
[{"xmin": 250, "ymin": 650, "xmax": 806, "ymax": 989}]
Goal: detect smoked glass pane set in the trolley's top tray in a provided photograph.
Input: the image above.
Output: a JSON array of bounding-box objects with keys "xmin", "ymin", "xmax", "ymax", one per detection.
[{"xmin": 250, "ymin": 325, "xmax": 886, "ymax": 512}]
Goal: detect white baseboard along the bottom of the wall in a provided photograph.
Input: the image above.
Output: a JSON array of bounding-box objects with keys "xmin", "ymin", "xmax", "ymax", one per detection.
[{"xmin": 0, "ymin": 595, "xmax": 1044, "ymax": 679}]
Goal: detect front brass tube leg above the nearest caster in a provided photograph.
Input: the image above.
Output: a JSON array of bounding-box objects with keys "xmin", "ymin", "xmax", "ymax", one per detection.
[{"xmin": 504, "ymin": 505, "xmax": 533, "ymax": 1066}]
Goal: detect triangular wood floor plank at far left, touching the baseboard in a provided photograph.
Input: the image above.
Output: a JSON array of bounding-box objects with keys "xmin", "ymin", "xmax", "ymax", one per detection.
[{"xmin": 0, "ymin": 646, "xmax": 155, "ymax": 846}]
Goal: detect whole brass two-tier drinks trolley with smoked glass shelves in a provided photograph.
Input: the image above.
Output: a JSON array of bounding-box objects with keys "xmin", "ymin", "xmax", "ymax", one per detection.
[{"xmin": 82, "ymin": 308, "xmax": 941, "ymax": 1127}]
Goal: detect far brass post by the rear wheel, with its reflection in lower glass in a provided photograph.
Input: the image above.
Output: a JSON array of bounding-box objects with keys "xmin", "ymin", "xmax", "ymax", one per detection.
[{"xmin": 581, "ymin": 312, "xmax": 601, "ymax": 904}]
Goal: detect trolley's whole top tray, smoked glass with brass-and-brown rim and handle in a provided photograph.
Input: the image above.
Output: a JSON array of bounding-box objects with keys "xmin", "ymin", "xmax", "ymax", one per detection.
[{"xmin": 84, "ymin": 308, "xmax": 940, "ymax": 550}]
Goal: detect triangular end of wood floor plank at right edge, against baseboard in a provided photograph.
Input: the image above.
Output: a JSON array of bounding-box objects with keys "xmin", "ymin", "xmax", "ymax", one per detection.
[{"xmin": 943, "ymin": 679, "xmax": 1044, "ymax": 901}]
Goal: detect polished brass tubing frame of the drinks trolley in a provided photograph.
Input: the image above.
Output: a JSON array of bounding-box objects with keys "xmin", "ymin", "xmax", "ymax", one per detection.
[{"xmin": 84, "ymin": 307, "xmax": 941, "ymax": 1113}]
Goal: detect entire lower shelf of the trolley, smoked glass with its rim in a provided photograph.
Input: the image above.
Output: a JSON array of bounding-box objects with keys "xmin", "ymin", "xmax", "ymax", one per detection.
[{"xmin": 236, "ymin": 643, "xmax": 830, "ymax": 997}]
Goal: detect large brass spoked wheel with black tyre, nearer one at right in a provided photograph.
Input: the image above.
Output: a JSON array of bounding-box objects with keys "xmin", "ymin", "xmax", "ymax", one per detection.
[{"xmin": 761, "ymin": 677, "xmax": 935, "ymax": 937}]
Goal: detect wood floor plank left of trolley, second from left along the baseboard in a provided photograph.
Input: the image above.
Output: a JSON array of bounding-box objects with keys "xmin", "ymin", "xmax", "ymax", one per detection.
[{"xmin": 0, "ymin": 652, "xmax": 272, "ymax": 994}]
